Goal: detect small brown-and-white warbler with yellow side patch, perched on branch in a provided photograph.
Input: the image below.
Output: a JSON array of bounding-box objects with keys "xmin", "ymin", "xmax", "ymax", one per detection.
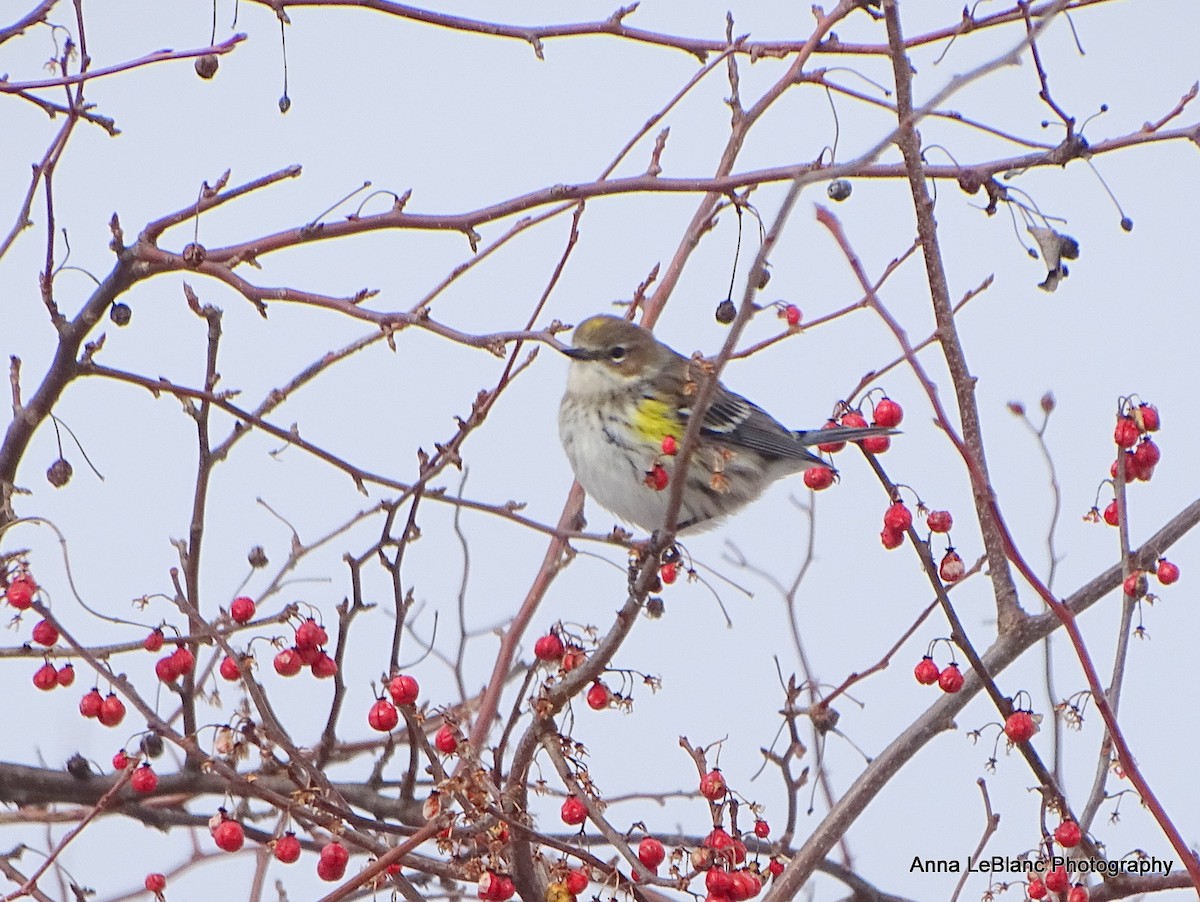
[{"xmin": 558, "ymin": 314, "xmax": 895, "ymax": 533}]
